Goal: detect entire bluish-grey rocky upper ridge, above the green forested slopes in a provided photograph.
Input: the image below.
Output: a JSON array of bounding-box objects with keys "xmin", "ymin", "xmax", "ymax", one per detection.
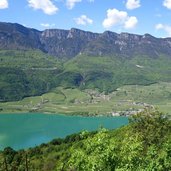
[{"xmin": 0, "ymin": 22, "xmax": 171, "ymax": 58}]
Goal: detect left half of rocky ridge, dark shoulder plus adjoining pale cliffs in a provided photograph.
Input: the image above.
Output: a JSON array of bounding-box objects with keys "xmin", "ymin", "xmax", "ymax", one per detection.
[{"xmin": 0, "ymin": 22, "xmax": 99, "ymax": 58}]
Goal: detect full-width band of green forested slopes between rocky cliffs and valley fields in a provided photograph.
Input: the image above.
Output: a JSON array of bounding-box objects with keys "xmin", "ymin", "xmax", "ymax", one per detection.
[{"xmin": 0, "ymin": 50, "xmax": 171, "ymax": 101}]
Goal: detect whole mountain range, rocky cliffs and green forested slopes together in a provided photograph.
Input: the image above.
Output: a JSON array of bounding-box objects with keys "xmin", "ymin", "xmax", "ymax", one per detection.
[{"xmin": 0, "ymin": 22, "xmax": 171, "ymax": 101}]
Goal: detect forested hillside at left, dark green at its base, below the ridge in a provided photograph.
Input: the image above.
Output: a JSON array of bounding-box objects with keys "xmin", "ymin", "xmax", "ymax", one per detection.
[{"xmin": 0, "ymin": 50, "xmax": 62, "ymax": 101}]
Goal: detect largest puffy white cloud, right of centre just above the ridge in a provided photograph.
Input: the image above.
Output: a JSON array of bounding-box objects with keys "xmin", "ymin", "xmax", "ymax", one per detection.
[{"xmin": 103, "ymin": 9, "xmax": 138, "ymax": 29}]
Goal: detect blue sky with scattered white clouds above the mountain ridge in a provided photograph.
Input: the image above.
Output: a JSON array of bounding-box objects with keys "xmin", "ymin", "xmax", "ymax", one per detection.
[{"xmin": 0, "ymin": 0, "xmax": 171, "ymax": 37}]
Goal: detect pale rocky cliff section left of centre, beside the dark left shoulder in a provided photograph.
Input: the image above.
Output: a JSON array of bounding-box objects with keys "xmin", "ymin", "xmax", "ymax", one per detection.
[{"xmin": 40, "ymin": 28, "xmax": 98, "ymax": 58}]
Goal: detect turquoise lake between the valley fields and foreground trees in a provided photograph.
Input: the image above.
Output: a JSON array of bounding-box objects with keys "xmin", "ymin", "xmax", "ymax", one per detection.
[{"xmin": 0, "ymin": 113, "xmax": 128, "ymax": 150}]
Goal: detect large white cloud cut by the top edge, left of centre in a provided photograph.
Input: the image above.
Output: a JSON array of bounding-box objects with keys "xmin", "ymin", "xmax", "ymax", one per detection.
[{"xmin": 28, "ymin": 0, "xmax": 58, "ymax": 15}]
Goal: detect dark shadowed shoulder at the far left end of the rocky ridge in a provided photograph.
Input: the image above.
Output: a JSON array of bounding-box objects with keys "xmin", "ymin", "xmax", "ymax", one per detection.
[{"xmin": 0, "ymin": 22, "xmax": 44, "ymax": 51}]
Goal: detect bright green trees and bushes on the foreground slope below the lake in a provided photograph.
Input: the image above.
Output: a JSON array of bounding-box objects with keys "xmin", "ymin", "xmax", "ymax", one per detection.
[{"xmin": 0, "ymin": 109, "xmax": 171, "ymax": 171}]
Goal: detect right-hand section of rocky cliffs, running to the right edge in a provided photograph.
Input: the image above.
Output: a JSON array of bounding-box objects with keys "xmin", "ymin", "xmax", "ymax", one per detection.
[{"xmin": 84, "ymin": 31, "xmax": 171, "ymax": 58}]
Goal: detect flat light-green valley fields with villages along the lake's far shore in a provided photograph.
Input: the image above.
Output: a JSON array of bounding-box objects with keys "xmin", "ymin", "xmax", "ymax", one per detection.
[{"xmin": 0, "ymin": 82, "xmax": 171, "ymax": 115}]
